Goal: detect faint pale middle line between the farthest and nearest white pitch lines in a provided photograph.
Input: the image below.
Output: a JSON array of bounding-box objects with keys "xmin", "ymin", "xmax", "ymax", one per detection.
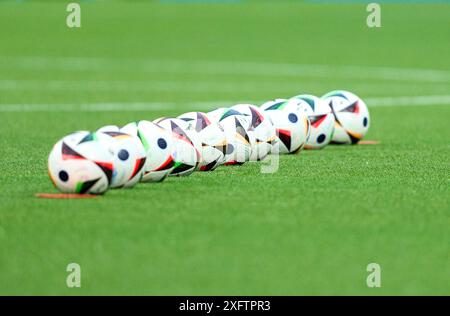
[{"xmin": 0, "ymin": 79, "xmax": 449, "ymax": 93}]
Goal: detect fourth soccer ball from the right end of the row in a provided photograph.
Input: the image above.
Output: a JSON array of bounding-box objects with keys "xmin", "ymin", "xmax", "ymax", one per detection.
[{"xmin": 231, "ymin": 104, "xmax": 277, "ymax": 161}]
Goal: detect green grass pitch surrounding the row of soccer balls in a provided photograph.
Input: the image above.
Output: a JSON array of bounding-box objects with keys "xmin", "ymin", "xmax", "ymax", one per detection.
[{"xmin": 0, "ymin": 1, "xmax": 450, "ymax": 295}]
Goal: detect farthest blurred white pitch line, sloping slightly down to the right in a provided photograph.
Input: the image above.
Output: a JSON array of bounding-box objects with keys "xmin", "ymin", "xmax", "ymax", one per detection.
[{"xmin": 0, "ymin": 56, "xmax": 450, "ymax": 82}]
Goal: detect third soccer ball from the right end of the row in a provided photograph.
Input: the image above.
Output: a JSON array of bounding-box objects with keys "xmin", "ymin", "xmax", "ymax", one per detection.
[{"xmin": 260, "ymin": 99, "xmax": 311, "ymax": 154}]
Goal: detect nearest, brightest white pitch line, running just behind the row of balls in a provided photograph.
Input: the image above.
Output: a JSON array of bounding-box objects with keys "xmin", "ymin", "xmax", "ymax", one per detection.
[{"xmin": 0, "ymin": 95, "xmax": 450, "ymax": 112}]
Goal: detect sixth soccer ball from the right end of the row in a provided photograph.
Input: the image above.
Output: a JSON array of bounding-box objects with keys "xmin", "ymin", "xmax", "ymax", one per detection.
[{"xmin": 178, "ymin": 112, "xmax": 227, "ymax": 171}]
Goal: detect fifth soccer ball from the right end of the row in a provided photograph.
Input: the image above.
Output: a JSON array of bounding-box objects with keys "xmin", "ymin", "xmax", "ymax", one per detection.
[{"xmin": 208, "ymin": 109, "xmax": 255, "ymax": 165}]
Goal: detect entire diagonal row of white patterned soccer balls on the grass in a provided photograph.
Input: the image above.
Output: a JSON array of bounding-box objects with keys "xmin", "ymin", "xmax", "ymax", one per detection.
[{"xmin": 48, "ymin": 90, "xmax": 369, "ymax": 194}]
